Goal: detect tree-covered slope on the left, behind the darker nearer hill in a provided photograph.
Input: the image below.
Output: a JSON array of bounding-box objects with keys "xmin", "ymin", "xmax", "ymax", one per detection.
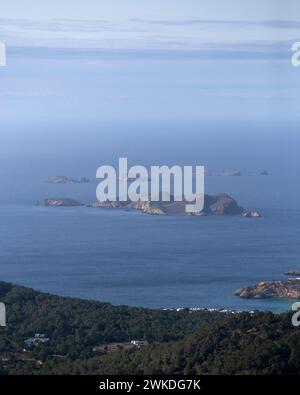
[{"xmin": 0, "ymin": 282, "xmax": 220, "ymax": 359}]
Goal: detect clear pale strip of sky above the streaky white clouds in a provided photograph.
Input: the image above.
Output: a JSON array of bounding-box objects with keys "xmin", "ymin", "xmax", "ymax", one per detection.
[{"xmin": 1, "ymin": 0, "xmax": 300, "ymax": 20}]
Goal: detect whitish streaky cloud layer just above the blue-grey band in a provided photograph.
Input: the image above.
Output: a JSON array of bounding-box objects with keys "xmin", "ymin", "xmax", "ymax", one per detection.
[{"xmin": 0, "ymin": 19, "xmax": 300, "ymax": 59}]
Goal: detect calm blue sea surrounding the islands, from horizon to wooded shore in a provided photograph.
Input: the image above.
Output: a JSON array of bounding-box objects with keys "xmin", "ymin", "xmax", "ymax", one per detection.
[{"xmin": 0, "ymin": 120, "xmax": 300, "ymax": 311}]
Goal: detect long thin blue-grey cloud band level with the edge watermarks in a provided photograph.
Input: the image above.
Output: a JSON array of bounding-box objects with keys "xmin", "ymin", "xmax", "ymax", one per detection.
[{"xmin": 9, "ymin": 42, "xmax": 290, "ymax": 67}]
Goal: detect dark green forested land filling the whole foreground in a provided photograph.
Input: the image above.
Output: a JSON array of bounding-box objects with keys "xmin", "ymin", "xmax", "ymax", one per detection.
[{"xmin": 0, "ymin": 283, "xmax": 300, "ymax": 374}]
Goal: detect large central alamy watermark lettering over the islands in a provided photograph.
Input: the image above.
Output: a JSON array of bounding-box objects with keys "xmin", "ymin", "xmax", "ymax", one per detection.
[{"xmin": 96, "ymin": 158, "xmax": 204, "ymax": 213}]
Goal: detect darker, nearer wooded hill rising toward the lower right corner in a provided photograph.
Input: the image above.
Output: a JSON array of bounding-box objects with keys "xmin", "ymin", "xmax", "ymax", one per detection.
[{"xmin": 37, "ymin": 313, "xmax": 300, "ymax": 375}]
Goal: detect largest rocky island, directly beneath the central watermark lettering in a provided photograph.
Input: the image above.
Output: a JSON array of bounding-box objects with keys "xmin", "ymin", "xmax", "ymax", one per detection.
[{"xmin": 89, "ymin": 193, "xmax": 244, "ymax": 216}]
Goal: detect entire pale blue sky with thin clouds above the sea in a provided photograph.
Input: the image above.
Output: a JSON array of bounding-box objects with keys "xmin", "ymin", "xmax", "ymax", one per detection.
[{"xmin": 0, "ymin": 0, "xmax": 300, "ymax": 123}]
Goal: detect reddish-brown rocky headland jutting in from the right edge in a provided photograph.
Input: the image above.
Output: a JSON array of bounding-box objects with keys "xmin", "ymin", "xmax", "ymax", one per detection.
[{"xmin": 235, "ymin": 279, "xmax": 300, "ymax": 299}]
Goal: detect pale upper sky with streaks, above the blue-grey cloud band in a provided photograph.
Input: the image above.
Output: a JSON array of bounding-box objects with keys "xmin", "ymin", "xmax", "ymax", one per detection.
[{"xmin": 0, "ymin": 0, "xmax": 300, "ymax": 49}]
